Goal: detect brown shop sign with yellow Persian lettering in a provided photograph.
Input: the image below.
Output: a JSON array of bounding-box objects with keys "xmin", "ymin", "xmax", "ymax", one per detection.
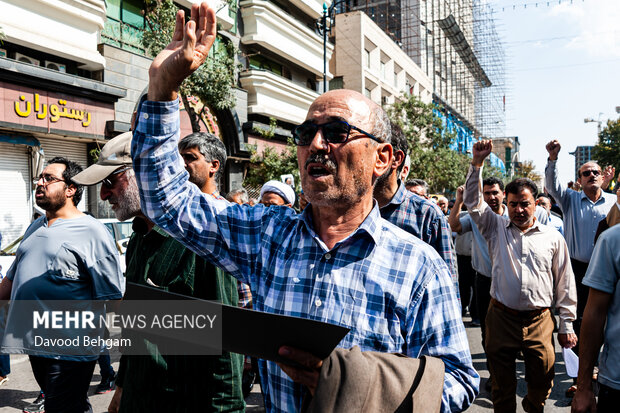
[{"xmin": 0, "ymin": 82, "xmax": 114, "ymax": 136}]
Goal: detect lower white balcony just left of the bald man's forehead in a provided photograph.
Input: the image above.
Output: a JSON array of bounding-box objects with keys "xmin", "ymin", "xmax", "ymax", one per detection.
[{"xmin": 239, "ymin": 70, "xmax": 319, "ymax": 123}]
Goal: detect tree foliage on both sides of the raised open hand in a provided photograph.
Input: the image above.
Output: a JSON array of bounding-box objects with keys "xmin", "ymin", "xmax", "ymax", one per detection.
[{"xmin": 142, "ymin": 0, "xmax": 239, "ymax": 132}]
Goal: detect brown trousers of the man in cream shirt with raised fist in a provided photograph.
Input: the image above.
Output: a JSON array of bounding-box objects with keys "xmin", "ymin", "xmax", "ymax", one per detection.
[{"xmin": 486, "ymin": 303, "xmax": 555, "ymax": 413}]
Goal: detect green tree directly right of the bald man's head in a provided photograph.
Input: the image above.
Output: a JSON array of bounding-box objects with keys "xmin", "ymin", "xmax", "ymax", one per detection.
[{"xmin": 388, "ymin": 94, "xmax": 470, "ymax": 192}]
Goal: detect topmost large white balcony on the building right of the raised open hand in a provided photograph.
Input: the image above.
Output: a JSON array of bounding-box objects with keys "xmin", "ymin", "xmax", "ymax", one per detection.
[{"xmin": 240, "ymin": 0, "xmax": 334, "ymax": 79}]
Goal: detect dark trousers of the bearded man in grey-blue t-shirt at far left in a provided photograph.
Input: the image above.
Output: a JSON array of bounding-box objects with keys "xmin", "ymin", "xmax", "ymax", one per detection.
[{"xmin": 30, "ymin": 356, "xmax": 96, "ymax": 413}]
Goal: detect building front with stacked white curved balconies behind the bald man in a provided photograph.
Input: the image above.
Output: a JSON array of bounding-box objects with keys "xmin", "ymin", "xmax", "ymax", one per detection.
[{"xmin": 239, "ymin": 0, "xmax": 333, "ymax": 163}]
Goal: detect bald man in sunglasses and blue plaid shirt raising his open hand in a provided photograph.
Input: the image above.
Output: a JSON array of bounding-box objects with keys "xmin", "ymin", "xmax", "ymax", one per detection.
[{"xmin": 132, "ymin": 3, "xmax": 479, "ymax": 413}]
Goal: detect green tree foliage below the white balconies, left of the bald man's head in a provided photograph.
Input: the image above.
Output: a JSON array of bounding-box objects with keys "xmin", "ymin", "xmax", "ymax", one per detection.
[{"xmin": 243, "ymin": 138, "xmax": 300, "ymax": 190}]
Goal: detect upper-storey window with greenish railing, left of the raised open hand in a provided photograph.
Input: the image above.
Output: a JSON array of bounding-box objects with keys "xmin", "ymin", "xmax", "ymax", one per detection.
[{"xmin": 101, "ymin": 0, "xmax": 145, "ymax": 54}]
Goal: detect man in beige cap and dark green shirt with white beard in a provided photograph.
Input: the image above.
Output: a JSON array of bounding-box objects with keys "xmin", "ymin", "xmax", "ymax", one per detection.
[{"xmin": 75, "ymin": 132, "xmax": 245, "ymax": 413}]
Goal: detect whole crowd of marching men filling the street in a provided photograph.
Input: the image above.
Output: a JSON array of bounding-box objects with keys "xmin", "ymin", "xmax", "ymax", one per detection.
[{"xmin": 0, "ymin": 3, "xmax": 620, "ymax": 413}]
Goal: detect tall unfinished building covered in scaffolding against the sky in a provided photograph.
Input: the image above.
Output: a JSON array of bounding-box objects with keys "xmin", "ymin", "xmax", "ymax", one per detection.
[{"xmin": 336, "ymin": 0, "xmax": 506, "ymax": 142}]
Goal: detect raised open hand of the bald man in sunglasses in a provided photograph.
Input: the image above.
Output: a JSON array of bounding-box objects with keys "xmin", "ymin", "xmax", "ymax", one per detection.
[{"xmin": 148, "ymin": 2, "xmax": 217, "ymax": 101}]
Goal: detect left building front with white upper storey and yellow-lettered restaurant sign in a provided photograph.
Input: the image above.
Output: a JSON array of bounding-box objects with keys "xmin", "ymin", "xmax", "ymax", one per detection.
[{"xmin": 0, "ymin": 0, "xmax": 126, "ymax": 246}]
